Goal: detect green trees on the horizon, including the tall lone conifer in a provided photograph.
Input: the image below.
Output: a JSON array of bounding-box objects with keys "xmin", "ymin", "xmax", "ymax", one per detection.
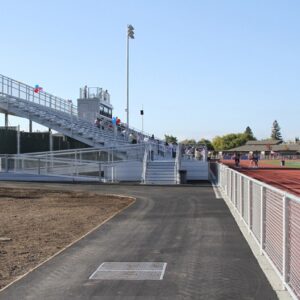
[{"xmin": 165, "ymin": 120, "xmax": 282, "ymax": 151}]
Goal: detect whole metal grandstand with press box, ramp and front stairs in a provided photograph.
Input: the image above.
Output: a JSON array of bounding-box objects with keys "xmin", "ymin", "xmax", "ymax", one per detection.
[{"xmin": 0, "ymin": 75, "xmax": 208, "ymax": 184}]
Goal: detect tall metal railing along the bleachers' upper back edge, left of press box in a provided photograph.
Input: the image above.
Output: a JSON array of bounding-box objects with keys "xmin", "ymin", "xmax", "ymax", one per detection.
[{"xmin": 0, "ymin": 75, "xmax": 77, "ymax": 116}]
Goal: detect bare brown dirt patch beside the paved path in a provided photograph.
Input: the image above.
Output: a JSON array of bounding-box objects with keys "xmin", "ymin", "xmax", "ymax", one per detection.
[{"xmin": 0, "ymin": 188, "xmax": 134, "ymax": 289}]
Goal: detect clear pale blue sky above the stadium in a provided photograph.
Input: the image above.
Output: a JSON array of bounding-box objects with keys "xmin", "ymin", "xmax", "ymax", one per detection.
[{"xmin": 0, "ymin": 0, "xmax": 300, "ymax": 140}]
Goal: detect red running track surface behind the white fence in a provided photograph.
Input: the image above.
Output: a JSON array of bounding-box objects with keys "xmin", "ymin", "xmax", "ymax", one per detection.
[{"xmin": 222, "ymin": 160, "xmax": 300, "ymax": 196}]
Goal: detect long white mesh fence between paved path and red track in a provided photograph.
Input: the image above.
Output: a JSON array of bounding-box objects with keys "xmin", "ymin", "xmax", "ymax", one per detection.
[{"xmin": 210, "ymin": 163, "xmax": 300, "ymax": 299}]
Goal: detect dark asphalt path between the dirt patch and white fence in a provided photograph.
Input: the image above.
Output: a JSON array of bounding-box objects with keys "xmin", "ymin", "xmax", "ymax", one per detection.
[{"xmin": 0, "ymin": 183, "xmax": 277, "ymax": 300}]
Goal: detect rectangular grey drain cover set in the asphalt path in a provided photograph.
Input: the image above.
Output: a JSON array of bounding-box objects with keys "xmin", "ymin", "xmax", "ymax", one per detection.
[{"xmin": 89, "ymin": 262, "xmax": 167, "ymax": 280}]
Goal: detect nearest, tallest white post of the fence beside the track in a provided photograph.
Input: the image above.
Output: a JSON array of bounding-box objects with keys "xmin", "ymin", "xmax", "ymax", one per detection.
[{"xmin": 282, "ymin": 195, "xmax": 289, "ymax": 289}]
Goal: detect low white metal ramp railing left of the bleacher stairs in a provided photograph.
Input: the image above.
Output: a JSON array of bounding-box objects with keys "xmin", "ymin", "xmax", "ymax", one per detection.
[{"xmin": 0, "ymin": 155, "xmax": 142, "ymax": 182}]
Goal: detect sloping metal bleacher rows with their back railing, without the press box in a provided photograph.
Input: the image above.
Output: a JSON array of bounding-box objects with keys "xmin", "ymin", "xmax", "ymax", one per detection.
[{"xmin": 0, "ymin": 75, "xmax": 129, "ymax": 148}]
